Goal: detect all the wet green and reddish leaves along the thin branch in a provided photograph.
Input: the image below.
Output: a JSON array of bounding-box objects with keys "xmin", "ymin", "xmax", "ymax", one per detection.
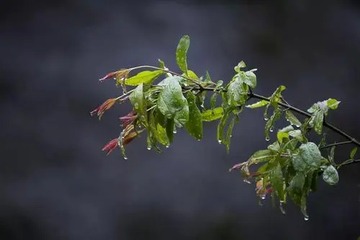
[{"xmin": 91, "ymin": 36, "xmax": 357, "ymax": 219}]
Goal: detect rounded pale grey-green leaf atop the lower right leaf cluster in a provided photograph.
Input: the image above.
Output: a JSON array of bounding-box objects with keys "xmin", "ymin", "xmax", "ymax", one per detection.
[{"xmin": 299, "ymin": 142, "xmax": 322, "ymax": 169}]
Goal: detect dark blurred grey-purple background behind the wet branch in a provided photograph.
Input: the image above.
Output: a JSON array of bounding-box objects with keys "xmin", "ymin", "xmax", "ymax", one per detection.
[{"xmin": 0, "ymin": 0, "xmax": 360, "ymax": 240}]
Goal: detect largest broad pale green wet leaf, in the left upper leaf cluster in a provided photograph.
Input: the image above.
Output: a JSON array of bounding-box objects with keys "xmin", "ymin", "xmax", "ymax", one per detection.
[{"xmin": 157, "ymin": 76, "xmax": 189, "ymax": 126}]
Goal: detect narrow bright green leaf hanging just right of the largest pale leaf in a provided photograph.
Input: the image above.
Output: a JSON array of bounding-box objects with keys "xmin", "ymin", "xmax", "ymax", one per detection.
[{"xmin": 185, "ymin": 92, "xmax": 203, "ymax": 140}]
